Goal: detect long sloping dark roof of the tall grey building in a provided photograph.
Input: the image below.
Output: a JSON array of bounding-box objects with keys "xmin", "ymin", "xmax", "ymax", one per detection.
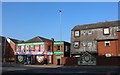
[{"xmin": 72, "ymin": 20, "xmax": 120, "ymax": 30}]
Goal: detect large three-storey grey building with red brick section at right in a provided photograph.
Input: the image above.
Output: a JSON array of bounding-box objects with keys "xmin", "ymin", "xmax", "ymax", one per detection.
[{"xmin": 71, "ymin": 21, "xmax": 120, "ymax": 65}]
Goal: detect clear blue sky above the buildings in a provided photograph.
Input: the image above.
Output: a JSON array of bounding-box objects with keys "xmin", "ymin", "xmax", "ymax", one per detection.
[{"xmin": 2, "ymin": 2, "xmax": 118, "ymax": 42}]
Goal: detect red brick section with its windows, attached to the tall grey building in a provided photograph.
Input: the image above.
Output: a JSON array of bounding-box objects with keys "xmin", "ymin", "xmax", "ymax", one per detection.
[{"xmin": 98, "ymin": 31, "xmax": 120, "ymax": 57}]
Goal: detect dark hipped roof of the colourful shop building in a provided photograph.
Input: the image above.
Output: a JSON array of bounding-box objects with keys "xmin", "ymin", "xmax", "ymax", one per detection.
[{"xmin": 25, "ymin": 36, "xmax": 51, "ymax": 43}]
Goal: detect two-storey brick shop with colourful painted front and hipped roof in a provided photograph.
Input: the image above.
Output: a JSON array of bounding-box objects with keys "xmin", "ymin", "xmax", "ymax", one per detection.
[{"xmin": 16, "ymin": 36, "xmax": 53, "ymax": 64}]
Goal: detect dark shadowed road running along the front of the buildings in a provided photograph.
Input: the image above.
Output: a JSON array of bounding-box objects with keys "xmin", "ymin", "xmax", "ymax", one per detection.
[{"xmin": 2, "ymin": 65, "xmax": 120, "ymax": 75}]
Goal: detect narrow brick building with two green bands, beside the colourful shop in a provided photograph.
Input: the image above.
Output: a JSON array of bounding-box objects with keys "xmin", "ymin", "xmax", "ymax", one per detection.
[{"xmin": 53, "ymin": 41, "xmax": 70, "ymax": 65}]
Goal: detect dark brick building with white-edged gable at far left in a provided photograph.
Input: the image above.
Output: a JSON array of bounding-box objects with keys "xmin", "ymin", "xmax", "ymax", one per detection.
[{"xmin": 0, "ymin": 36, "xmax": 22, "ymax": 62}]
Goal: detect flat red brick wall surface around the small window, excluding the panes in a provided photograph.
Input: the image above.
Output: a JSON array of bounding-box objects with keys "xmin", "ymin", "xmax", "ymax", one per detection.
[{"xmin": 98, "ymin": 40, "xmax": 118, "ymax": 56}]
